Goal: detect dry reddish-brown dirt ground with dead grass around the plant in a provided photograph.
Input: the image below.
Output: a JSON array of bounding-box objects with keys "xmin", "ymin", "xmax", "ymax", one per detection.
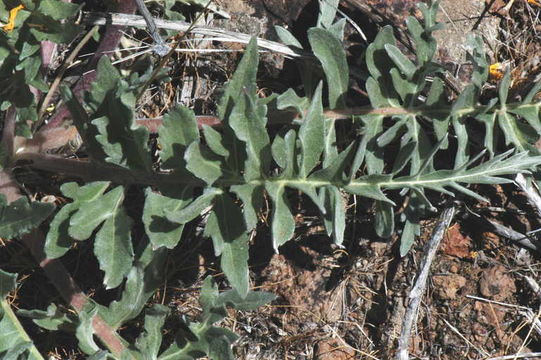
[{"xmin": 3, "ymin": 0, "xmax": 541, "ymax": 360}]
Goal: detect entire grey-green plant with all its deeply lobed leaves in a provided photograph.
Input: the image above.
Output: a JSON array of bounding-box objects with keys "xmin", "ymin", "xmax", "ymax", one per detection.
[{"xmin": 0, "ymin": 0, "xmax": 541, "ymax": 359}]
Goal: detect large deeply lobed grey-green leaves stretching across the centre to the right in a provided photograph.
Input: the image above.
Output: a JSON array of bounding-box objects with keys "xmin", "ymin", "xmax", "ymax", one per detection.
[{"xmin": 51, "ymin": 2, "xmax": 541, "ymax": 296}]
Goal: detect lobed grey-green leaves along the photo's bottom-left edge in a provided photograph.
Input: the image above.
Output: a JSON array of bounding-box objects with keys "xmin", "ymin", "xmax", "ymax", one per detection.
[{"xmin": 16, "ymin": 278, "xmax": 275, "ymax": 360}]
